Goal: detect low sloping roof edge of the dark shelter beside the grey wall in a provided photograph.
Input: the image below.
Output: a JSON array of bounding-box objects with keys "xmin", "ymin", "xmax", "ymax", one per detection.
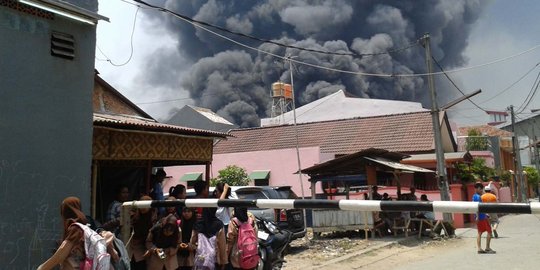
[{"xmin": 94, "ymin": 113, "xmax": 229, "ymax": 138}]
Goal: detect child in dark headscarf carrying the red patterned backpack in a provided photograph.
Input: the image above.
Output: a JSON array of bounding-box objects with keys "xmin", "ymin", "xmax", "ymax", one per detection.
[{"xmin": 227, "ymin": 207, "xmax": 257, "ymax": 269}]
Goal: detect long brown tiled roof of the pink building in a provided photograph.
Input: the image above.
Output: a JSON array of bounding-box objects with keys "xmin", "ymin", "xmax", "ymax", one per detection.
[{"xmin": 214, "ymin": 111, "xmax": 435, "ymax": 154}]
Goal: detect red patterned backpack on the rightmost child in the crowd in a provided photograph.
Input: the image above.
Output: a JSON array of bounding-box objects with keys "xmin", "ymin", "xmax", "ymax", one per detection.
[{"xmin": 233, "ymin": 218, "xmax": 260, "ymax": 269}]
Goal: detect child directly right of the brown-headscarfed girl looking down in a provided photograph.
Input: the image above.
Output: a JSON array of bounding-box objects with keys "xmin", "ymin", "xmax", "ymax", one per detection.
[{"xmin": 177, "ymin": 207, "xmax": 196, "ymax": 270}]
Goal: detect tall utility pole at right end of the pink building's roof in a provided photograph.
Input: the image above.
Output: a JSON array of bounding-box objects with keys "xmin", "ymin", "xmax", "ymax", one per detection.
[{"xmin": 422, "ymin": 34, "xmax": 452, "ymax": 222}]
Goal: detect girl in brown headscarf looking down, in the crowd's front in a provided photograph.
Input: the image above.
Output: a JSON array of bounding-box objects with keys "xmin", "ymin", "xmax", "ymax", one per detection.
[{"xmin": 145, "ymin": 215, "xmax": 180, "ymax": 270}]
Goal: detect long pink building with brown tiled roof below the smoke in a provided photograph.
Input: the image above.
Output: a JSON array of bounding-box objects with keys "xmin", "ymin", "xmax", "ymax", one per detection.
[{"xmin": 165, "ymin": 111, "xmax": 456, "ymax": 199}]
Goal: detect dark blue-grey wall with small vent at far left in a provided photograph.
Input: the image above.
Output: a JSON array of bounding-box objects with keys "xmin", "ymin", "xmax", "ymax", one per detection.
[{"xmin": 0, "ymin": 1, "xmax": 97, "ymax": 270}]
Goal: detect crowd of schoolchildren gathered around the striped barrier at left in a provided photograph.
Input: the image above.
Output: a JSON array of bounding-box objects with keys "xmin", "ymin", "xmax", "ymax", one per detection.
[{"xmin": 38, "ymin": 172, "xmax": 257, "ymax": 270}]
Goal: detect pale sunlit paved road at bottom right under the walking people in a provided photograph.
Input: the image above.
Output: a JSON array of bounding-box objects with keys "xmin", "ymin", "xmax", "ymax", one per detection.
[{"xmin": 376, "ymin": 215, "xmax": 540, "ymax": 270}]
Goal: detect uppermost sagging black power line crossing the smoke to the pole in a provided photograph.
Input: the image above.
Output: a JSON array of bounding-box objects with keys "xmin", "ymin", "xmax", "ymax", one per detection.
[{"xmin": 130, "ymin": 0, "xmax": 419, "ymax": 57}]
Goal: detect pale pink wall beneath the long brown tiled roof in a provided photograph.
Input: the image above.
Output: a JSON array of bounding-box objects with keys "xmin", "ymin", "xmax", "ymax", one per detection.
[{"xmin": 163, "ymin": 147, "xmax": 334, "ymax": 197}]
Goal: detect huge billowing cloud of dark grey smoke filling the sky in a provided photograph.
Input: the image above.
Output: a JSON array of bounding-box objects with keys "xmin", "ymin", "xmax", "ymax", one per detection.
[{"xmin": 142, "ymin": 0, "xmax": 483, "ymax": 127}]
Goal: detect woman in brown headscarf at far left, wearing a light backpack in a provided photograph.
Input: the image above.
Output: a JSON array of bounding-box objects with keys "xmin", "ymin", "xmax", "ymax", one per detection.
[{"xmin": 38, "ymin": 197, "xmax": 87, "ymax": 270}]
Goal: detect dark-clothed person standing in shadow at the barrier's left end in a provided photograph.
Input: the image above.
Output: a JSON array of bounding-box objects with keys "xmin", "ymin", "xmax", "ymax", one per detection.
[{"xmin": 127, "ymin": 196, "xmax": 157, "ymax": 270}]
